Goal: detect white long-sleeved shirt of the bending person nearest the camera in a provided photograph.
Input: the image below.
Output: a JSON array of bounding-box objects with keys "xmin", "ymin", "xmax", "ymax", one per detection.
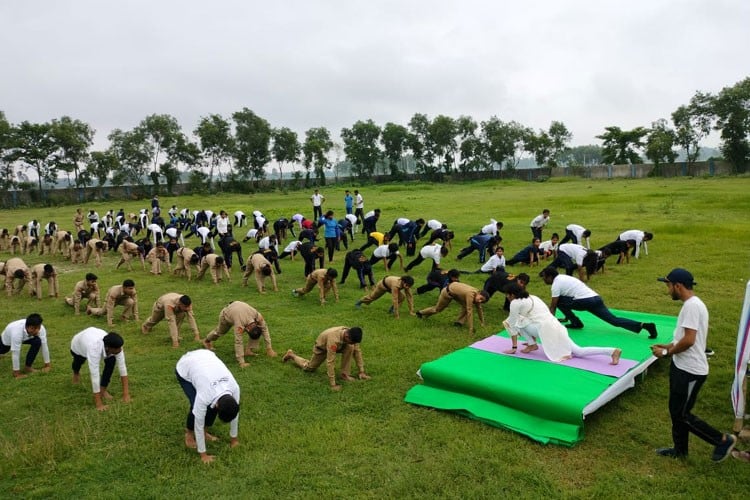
[{"xmin": 177, "ymin": 349, "xmax": 240, "ymax": 453}]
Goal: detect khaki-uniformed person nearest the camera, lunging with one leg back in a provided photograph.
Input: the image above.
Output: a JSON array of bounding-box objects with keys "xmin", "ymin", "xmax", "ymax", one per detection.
[{"xmin": 281, "ymin": 326, "xmax": 370, "ymax": 391}]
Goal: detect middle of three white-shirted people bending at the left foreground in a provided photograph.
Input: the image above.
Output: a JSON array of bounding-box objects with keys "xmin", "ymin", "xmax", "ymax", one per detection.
[{"xmin": 70, "ymin": 327, "xmax": 130, "ymax": 411}]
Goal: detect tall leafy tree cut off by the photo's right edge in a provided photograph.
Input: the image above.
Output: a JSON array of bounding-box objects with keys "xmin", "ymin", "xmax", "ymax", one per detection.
[{"xmin": 712, "ymin": 78, "xmax": 750, "ymax": 173}]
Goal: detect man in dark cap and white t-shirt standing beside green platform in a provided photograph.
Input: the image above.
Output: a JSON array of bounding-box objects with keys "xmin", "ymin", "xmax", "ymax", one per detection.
[{"xmin": 651, "ymin": 268, "xmax": 737, "ymax": 462}]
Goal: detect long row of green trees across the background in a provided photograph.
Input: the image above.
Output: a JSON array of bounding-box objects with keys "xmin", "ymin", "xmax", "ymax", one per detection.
[{"xmin": 0, "ymin": 78, "xmax": 750, "ymax": 196}]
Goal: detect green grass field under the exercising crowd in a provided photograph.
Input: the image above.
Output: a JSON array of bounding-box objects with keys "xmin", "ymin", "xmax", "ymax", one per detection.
[{"xmin": 0, "ymin": 177, "xmax": 750, "ymax": 498}]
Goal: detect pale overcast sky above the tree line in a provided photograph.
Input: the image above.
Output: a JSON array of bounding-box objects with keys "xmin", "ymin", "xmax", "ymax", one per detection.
[{"xmin": 0, "ymin": 0, "xmax": 750, "ymax": 149}]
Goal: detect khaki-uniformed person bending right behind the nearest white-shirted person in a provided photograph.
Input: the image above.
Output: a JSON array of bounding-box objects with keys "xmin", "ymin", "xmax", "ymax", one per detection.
[{"xmin": 203, "ymin": 301, "xmax": 276, "ymax": 368}]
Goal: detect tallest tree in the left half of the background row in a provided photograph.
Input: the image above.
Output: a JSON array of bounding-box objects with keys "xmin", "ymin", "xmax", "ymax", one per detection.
[{"xmin": 232, "ymin": 108, "xmax": 272, "ymax": 181}]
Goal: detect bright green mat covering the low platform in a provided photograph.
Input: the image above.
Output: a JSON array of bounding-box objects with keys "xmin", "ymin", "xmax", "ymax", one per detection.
[{"xmin": 404, "ymin": 310, "xmax": 676, "ymax": 446}]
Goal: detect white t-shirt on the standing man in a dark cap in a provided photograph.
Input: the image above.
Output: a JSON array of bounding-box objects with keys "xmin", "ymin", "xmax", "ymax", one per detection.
[{"xmin": 672, "ymin": 295, "xmax": 708, "ymax": 375}]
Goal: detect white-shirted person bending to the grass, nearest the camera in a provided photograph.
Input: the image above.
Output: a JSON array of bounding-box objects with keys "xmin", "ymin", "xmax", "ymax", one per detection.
[{"xmin": 175, "ymin": 349, "xmax": 240, "ymax": 463}]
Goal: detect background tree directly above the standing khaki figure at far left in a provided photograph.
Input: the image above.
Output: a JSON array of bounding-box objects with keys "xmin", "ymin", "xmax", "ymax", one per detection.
[{"xmin": 51, "ymin": 116, "xmax": 94, "ymax": 187}]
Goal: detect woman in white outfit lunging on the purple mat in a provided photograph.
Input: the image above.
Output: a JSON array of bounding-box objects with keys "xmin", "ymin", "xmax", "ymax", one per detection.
[{"xmin": 503, "ymin": 283, "xmax": 622, "ymax": 365}]
